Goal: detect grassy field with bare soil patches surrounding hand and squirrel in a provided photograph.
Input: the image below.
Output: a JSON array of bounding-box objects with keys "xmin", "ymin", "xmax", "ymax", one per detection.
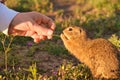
[{"xmin": 0, "ymin": 0, "xmax": 120, "ymax": 80}]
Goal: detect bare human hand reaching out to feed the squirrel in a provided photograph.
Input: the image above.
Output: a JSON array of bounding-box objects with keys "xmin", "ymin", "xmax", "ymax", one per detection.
[{"xmin": 8, "ymin": 12, "xmax": 55, "ymax": 42}]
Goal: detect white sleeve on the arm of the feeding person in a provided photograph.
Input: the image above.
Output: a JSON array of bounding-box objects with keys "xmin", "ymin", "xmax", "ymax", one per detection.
[{"xmin": 0, "ymin": 3, "xmax": 18, "ymax": 34}]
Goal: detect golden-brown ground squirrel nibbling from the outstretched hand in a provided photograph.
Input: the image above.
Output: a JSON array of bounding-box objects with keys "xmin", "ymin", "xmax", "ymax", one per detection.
[{"xmin": 60, "ymin": 27, "xmax": 120, "ymax": 79}]
